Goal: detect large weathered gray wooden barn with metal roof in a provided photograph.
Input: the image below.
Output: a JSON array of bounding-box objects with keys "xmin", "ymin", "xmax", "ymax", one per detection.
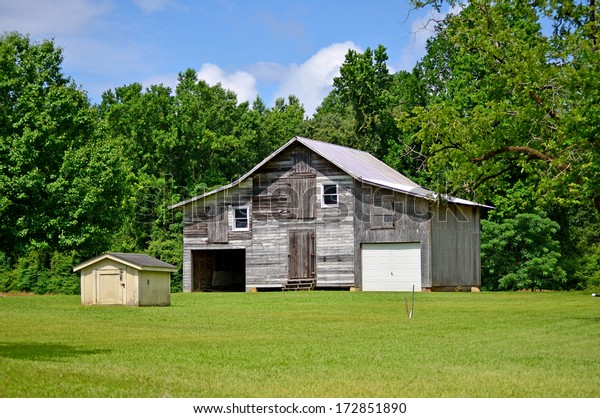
[{"xmin": 171, "ymin": 137, "xmax": 485, "ymax": 292}]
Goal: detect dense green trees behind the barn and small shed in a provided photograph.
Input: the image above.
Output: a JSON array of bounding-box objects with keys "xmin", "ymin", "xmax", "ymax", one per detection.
[{"xmin": 0, "ymin": 0, "xmax": 600, "ymax": 293}]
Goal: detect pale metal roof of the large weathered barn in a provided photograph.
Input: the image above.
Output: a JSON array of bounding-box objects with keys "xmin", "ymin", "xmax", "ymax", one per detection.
[{"xmin": 169, "ymin": 136, "xmax": 491, "ymax": 209}]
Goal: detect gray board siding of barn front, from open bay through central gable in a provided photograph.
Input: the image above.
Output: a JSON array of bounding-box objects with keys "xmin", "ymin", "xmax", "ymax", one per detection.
[{"xmin": 183, "ymin": 145, "xmax": 354, "ymax": 291}]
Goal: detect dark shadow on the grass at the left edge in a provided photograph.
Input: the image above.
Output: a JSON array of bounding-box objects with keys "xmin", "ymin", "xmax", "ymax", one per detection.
[{"xmin": 0, "ymin": 342, "xmax": 110, "ymax": 361}]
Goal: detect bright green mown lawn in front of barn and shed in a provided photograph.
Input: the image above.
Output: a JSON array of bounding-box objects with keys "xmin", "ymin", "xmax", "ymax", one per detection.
[{"xmin": 0, "ymin": 292, "xmax": 600, "ymax": 398}]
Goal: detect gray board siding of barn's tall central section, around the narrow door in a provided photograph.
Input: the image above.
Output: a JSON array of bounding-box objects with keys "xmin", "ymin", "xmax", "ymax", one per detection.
[{"xmin": 246, "ymin": 146, "xmax": 354, "ymax": 287}]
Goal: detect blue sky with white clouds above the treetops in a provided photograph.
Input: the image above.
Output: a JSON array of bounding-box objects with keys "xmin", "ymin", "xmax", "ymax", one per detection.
[{"xmin": 0, "ymin": 0, "xmax": 454, "ymax": 115}]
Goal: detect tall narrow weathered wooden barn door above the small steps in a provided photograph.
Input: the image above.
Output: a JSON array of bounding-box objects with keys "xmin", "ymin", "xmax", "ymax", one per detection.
[{"xmin": 288, "ymin": 229, "xmax": 316, "ymax": 280}]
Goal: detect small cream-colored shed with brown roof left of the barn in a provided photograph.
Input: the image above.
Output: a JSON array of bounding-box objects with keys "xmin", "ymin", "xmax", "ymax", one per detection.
[{"xmin": 73, "ymin": 253, "xmax": 177, "ymax": 306}]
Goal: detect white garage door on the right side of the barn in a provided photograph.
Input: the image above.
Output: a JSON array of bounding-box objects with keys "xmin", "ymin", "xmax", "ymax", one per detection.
[{"xmin": 362, "ymin": 242, "xmax": 421, "ymax": 291}]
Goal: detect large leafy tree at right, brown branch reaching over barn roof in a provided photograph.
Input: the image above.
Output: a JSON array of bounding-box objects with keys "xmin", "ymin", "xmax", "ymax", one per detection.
[{"xmin": 402, "ymin": 0, "xmax": 600, "ymax": 207}]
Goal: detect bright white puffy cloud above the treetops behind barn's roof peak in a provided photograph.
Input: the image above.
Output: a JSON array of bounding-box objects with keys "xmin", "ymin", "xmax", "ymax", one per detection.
[{"xmin": 275, "ymin": 42, "xmax": 360, "ymax": 116}]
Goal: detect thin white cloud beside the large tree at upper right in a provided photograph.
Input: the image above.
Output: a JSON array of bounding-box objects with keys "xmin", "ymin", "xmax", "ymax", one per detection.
[{"xmin": 398, "ymin": 4, "xmax": 464, "ymax": 71}]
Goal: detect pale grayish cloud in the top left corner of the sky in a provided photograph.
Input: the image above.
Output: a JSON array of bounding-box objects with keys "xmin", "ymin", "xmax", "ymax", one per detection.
[{"xmin": 0, "ymin": 0, "xmax": 112, "ymax": 36}]
